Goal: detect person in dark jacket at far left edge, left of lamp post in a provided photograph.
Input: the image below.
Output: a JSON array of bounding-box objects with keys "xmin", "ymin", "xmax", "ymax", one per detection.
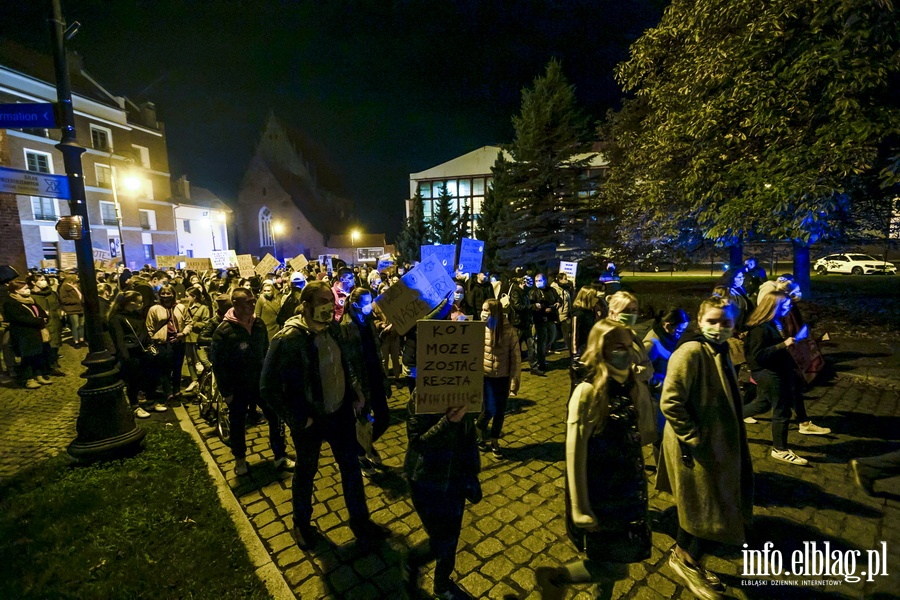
[{"xmin": 3, "ymin": 279, "xmax": 53, "ymax": 390}]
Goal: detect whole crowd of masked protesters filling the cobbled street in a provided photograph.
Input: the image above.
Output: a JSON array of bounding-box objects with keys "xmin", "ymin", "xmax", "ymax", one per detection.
[{"xmin": 2, "ymin": 259, "xmax": 863, "ymax": 598}]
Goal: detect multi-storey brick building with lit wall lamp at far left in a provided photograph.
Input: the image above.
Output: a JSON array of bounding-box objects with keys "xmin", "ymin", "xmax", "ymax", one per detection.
[{"xmin": 0, "ymin": 41, "xmax": 178, "ymax": 272}]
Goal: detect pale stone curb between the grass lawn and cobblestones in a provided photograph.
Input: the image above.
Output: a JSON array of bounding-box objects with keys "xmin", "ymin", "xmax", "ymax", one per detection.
[{"xmin": 173, "ymin": 406, "xmax": 297, "ymax": 600}]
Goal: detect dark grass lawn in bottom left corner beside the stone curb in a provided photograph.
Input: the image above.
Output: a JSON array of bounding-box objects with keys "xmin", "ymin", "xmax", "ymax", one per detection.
[{"xmin": 0, "ymin": 423, "xmax": 268, "ymax": 599}]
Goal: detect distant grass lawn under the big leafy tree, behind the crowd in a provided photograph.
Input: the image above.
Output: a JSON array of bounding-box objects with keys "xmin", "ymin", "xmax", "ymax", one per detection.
[{"xmin": 622, "ymin": 274, "xmax": 900, "ymax": 335}]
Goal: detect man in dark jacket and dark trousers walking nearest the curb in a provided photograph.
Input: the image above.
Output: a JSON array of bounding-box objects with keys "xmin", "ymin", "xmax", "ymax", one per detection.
[{"xmin": 210, "ymin": 288, "xmax": 294, "ymax": 475}]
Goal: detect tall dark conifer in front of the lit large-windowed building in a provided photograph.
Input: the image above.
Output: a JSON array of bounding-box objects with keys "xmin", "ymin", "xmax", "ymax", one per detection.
[{"xmin": 495, "ymin": 60, "xmax": 593, "ymax": 268}]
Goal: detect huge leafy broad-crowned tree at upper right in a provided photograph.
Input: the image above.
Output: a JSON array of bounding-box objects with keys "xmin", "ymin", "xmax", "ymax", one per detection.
[{"xmin": 608, "ymin": 0, "xmax": 900, "ymax": 288}]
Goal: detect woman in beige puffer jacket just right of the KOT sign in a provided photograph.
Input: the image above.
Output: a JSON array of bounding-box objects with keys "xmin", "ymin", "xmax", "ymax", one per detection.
[{"xmin": 475, "ymin": 298, "xmax": 522, "ymax": 458}]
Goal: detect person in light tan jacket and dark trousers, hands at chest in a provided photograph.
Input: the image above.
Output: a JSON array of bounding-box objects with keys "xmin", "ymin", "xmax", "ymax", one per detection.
[{"xmin": 146, "ymin": 285, "xmax": 192, "ymax": 410}]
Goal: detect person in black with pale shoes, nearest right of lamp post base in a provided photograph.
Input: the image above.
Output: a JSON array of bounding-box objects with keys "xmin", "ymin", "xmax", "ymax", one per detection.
[{"xmin": 109, "ymin": 290, "xmax": 156, "ymax": 419}]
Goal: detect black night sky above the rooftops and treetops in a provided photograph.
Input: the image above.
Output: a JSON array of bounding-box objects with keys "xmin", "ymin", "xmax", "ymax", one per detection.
[{"xmin": 0, "ymin": 0, "xmax": 666, "ymax": 239}]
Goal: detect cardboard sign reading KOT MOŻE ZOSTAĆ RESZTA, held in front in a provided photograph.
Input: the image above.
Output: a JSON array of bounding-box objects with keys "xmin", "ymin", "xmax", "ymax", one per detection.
[{"xmin": 416, "ymin": 321, "xmax": 485, "ymax": 414}]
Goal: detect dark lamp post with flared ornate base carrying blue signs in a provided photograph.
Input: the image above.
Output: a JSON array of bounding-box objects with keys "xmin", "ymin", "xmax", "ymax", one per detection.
[{"xmin": 50, "ymin": 0, "xmax": 146, "ymax": 462}]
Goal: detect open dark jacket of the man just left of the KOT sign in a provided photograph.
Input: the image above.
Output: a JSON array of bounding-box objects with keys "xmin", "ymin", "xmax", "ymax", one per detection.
[{"xmin": 260, "ymin": 315, "xmax": 363, "ymax": 433}]
